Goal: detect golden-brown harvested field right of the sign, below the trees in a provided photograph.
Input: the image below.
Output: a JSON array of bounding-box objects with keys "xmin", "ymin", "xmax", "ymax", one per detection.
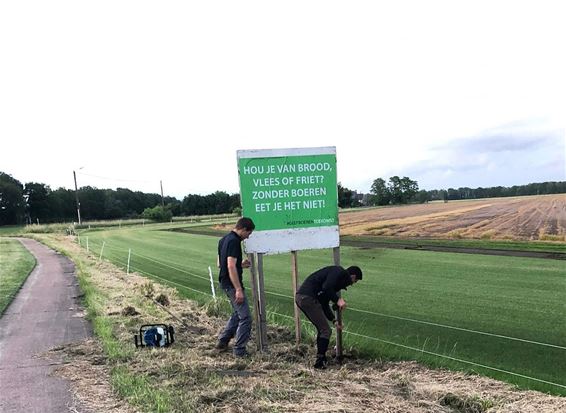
[{"xmin": 340, "ymin": 194, "xmax": 566, "ymax": 241}]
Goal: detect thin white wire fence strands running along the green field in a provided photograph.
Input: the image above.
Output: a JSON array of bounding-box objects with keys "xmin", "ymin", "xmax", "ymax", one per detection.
[{"xmin": 79, "ymin": 237, "xmax": 566, "ymax": 389}]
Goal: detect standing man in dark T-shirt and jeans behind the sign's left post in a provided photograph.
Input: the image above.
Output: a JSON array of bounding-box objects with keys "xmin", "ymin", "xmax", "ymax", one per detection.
[{"xmin": 216, "ymin": 217, "xmax": 255, "ymax": 357}]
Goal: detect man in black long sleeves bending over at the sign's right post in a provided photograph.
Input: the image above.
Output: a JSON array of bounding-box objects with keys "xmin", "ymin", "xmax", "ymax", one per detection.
[{"xmin": 295, "ymin": 265, "xmax": 362, "ymax": 369}]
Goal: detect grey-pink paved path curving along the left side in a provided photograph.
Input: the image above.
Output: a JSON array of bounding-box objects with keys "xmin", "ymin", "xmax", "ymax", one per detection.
[{"xmin": 0, "ymin": 238, "xmax": 92, "ymax": 413}]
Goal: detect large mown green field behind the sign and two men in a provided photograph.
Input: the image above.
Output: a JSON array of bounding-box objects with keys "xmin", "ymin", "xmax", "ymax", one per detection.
[{"xmin": 81, "ymin": 225, "xmax": 566, "ymax": 395}]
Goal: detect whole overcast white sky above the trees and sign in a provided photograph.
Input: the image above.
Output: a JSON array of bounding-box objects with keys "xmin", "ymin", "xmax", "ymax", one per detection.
[{"xmin": 0, "ymin": 0, "xmax": 566, "ymax": 199}]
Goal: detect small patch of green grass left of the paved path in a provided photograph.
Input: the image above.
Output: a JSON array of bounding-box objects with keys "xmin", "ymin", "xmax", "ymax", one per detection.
[{"xmin": 0, "ymin": 238, "xmax": 35, "ymax": 315}]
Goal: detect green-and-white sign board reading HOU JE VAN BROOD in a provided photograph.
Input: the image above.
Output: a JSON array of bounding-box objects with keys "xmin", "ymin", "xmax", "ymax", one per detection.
[{"xmin": 238, "ymin": 147, "xmax": 338, "ymax": 252}]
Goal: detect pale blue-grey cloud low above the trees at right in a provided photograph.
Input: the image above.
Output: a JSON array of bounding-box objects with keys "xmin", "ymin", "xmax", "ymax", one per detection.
[{"xmin": 403, "ymin": 122, "xmax": 566, "ymax": 187}]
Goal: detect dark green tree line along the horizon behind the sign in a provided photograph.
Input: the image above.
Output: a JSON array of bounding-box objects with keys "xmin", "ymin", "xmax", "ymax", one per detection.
[{"xmin": 0, "ymin": 172, "xmax": 566, "ymax": 225}]
